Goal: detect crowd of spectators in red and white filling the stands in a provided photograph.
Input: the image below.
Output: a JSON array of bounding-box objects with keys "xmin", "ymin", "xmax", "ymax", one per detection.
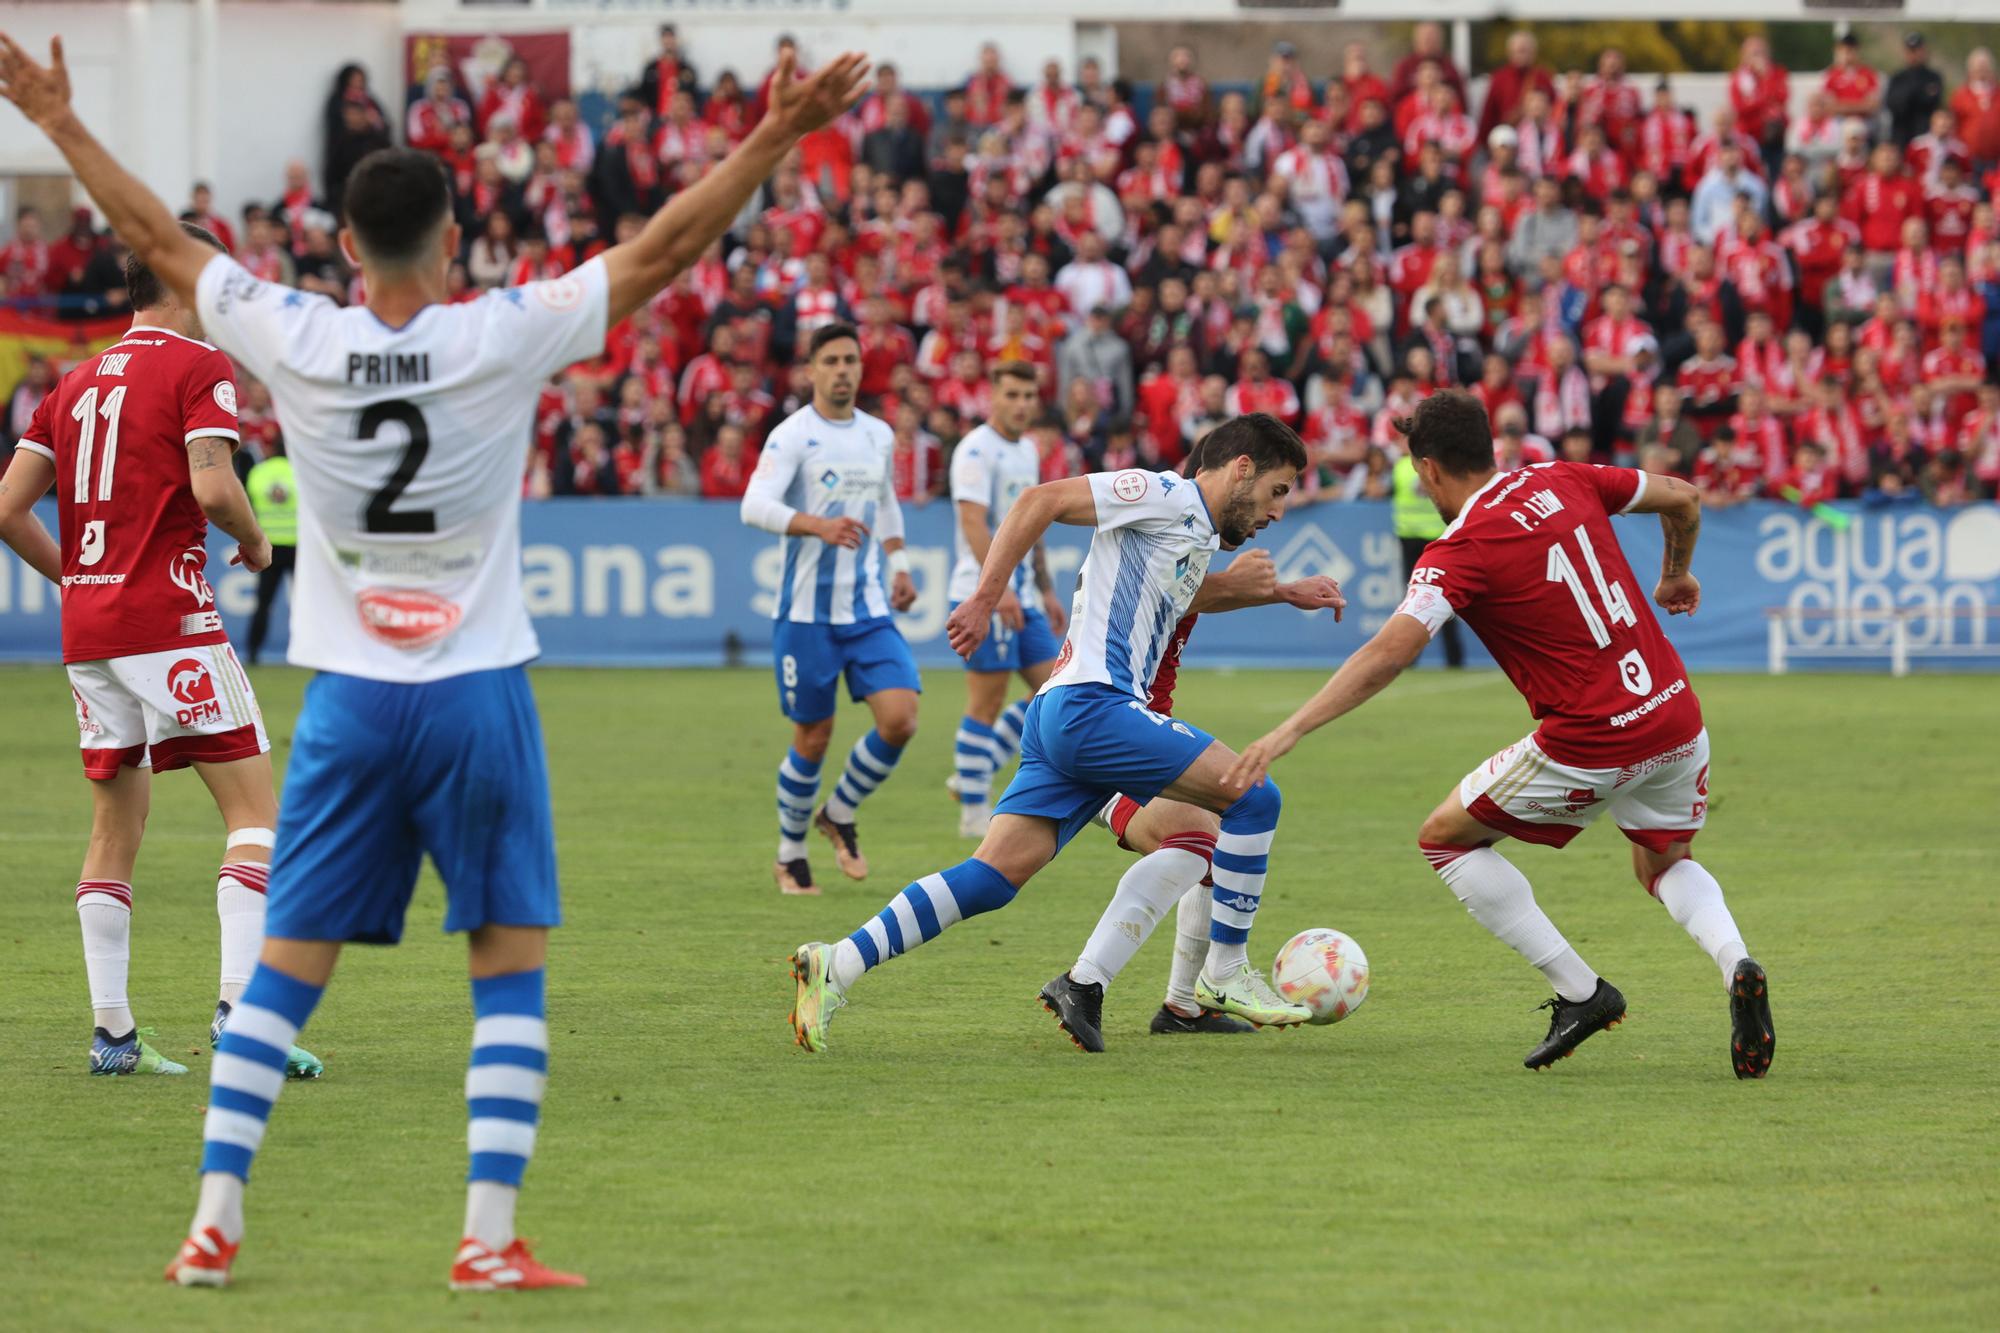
[{"xmin": 0, "ymin": 24, "xmax": 2000, "ymax": 504}]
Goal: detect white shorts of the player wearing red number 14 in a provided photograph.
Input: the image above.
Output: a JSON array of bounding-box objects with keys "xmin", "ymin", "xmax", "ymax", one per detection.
[{"xmin": 1458, "ymin": 729, "xmax": 1708, "ymax": 853}]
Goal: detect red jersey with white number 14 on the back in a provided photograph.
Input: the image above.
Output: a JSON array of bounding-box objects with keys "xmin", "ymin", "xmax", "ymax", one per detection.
[{"xmin": 1398, "ymin": 462, "xmax": 1702, "ymax": 769}]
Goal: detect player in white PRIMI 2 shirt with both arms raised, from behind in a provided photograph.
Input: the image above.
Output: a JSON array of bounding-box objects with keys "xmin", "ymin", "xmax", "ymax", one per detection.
[{"xmin": 0, "ymin": 36, "xmax": 866, "ymax": 1291}]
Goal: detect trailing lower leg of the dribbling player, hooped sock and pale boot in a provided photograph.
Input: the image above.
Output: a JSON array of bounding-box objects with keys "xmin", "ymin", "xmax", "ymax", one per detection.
[{"xmin": 792, "ymin": 815, "xmax": 1056, "ymax": 1051}]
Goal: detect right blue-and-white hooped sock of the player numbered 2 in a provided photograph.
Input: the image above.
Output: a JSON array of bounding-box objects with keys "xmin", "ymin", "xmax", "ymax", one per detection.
[{"xmin": 466, "ymin": 967, "xmax": 548, "ymax": 1249}]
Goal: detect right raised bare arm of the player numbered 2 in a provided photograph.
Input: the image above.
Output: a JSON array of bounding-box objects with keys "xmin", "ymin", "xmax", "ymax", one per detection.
[{"xmin": 604, "ymin": 50, "xmax": 868, "ymax": 324}]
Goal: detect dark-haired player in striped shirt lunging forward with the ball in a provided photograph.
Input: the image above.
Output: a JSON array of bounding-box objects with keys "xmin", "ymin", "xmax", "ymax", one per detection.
[{"xmin": 792, "ymin": 412, "xmax": 1312, "ymax": 1051}]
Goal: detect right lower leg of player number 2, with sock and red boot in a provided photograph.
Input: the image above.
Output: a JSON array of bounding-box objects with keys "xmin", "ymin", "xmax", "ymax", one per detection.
[{"xmin": 450, "ymin": 925, "xmax": 584, "ymax": 1291}]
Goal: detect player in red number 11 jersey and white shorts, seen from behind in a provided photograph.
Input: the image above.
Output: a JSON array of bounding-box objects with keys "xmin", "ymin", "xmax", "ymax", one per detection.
[{"xmin": 0, "ymin": 224, "xmax": 320, "ymax": 1077}]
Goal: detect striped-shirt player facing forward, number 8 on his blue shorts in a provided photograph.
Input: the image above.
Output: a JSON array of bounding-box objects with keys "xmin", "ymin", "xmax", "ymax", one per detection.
[{"xmin": 742, "ymin": 324, "xmax": 924, "ymax": 893}]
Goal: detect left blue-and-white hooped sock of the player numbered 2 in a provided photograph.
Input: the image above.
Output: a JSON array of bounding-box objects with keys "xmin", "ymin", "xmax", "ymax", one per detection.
[{"xmin": 192, "ymin": 963, "xmax": 324, "ymax": 1241}]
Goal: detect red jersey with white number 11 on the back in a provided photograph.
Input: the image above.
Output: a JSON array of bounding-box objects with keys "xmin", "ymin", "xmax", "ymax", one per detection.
[{"xmin": 18, "ymin": 324, "xmax": 238, "ymax": 662}]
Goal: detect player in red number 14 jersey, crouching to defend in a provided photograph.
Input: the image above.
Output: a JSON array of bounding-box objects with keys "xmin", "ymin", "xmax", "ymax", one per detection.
[{"xmin": 1228, "ymin": 392, "xmax": 1776, "ymax": 1079}]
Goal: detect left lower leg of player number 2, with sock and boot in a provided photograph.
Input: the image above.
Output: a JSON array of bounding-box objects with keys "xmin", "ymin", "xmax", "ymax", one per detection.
[{"xmin": 166, "ymin": 939, "xmax": 340, "ymax": 1287}]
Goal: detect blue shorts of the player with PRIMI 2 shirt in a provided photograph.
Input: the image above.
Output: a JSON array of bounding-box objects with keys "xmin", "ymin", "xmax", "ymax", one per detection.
[{"xmin": 264, "ymin": 667, "xmax": 562, "ymax": 932}]
